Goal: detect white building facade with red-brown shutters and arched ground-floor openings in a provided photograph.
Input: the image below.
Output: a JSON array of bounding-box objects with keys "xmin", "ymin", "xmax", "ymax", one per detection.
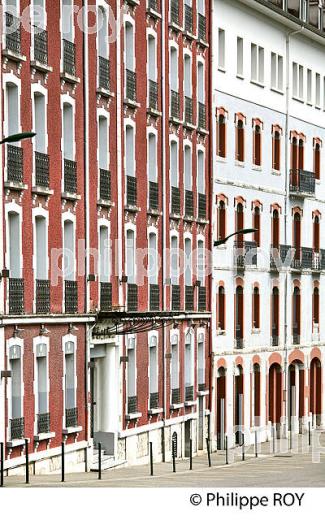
[{"xmin": 212, "ymin": 0, "xmax": 325, "ymax": 447}]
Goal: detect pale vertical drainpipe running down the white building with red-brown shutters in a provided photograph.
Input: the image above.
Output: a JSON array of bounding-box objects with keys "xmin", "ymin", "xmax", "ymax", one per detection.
[{"xmin": 283, "ymin": 27, "xmax": 304, "ymax": 436}]
